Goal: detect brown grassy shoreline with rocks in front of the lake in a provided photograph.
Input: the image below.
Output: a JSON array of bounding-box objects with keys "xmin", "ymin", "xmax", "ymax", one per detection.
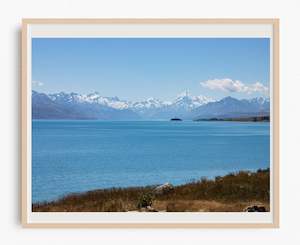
[{"xmin": 32, "ymin": 169, "xmax": 270, "ymax": 212}]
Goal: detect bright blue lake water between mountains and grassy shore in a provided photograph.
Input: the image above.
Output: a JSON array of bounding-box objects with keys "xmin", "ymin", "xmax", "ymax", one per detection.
[{"xmin": 32, "ymin": 120, "xmax": 270, "ymax": 202}]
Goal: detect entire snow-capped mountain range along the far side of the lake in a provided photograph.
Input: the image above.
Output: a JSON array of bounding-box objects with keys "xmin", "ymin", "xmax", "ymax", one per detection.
[{"xmin": 32, "ymin": 91, "xmax": 270, "ymax": 120}]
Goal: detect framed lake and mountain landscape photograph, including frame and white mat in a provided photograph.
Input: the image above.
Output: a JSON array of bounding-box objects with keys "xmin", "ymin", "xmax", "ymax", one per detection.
[{"xmin": 21, "ymin": 19, "xmax": 279, "ymax": 228}]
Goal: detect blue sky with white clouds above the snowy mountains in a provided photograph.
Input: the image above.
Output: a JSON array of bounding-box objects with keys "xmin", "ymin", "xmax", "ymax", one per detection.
[{"xmin": 32, "ymin": 38, "xmax": 270, "ymax": 101}]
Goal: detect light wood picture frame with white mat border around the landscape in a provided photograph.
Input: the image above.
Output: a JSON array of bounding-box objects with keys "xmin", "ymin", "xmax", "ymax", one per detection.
[{"xmin": 21, "ymin": 19, "xmax": 280, "ymax": 228}]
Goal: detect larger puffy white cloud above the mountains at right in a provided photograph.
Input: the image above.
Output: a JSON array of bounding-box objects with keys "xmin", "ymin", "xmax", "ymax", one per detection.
[{"xmin": 200, "ymin": 78, "xmax": 269, "ymax": 94}]
